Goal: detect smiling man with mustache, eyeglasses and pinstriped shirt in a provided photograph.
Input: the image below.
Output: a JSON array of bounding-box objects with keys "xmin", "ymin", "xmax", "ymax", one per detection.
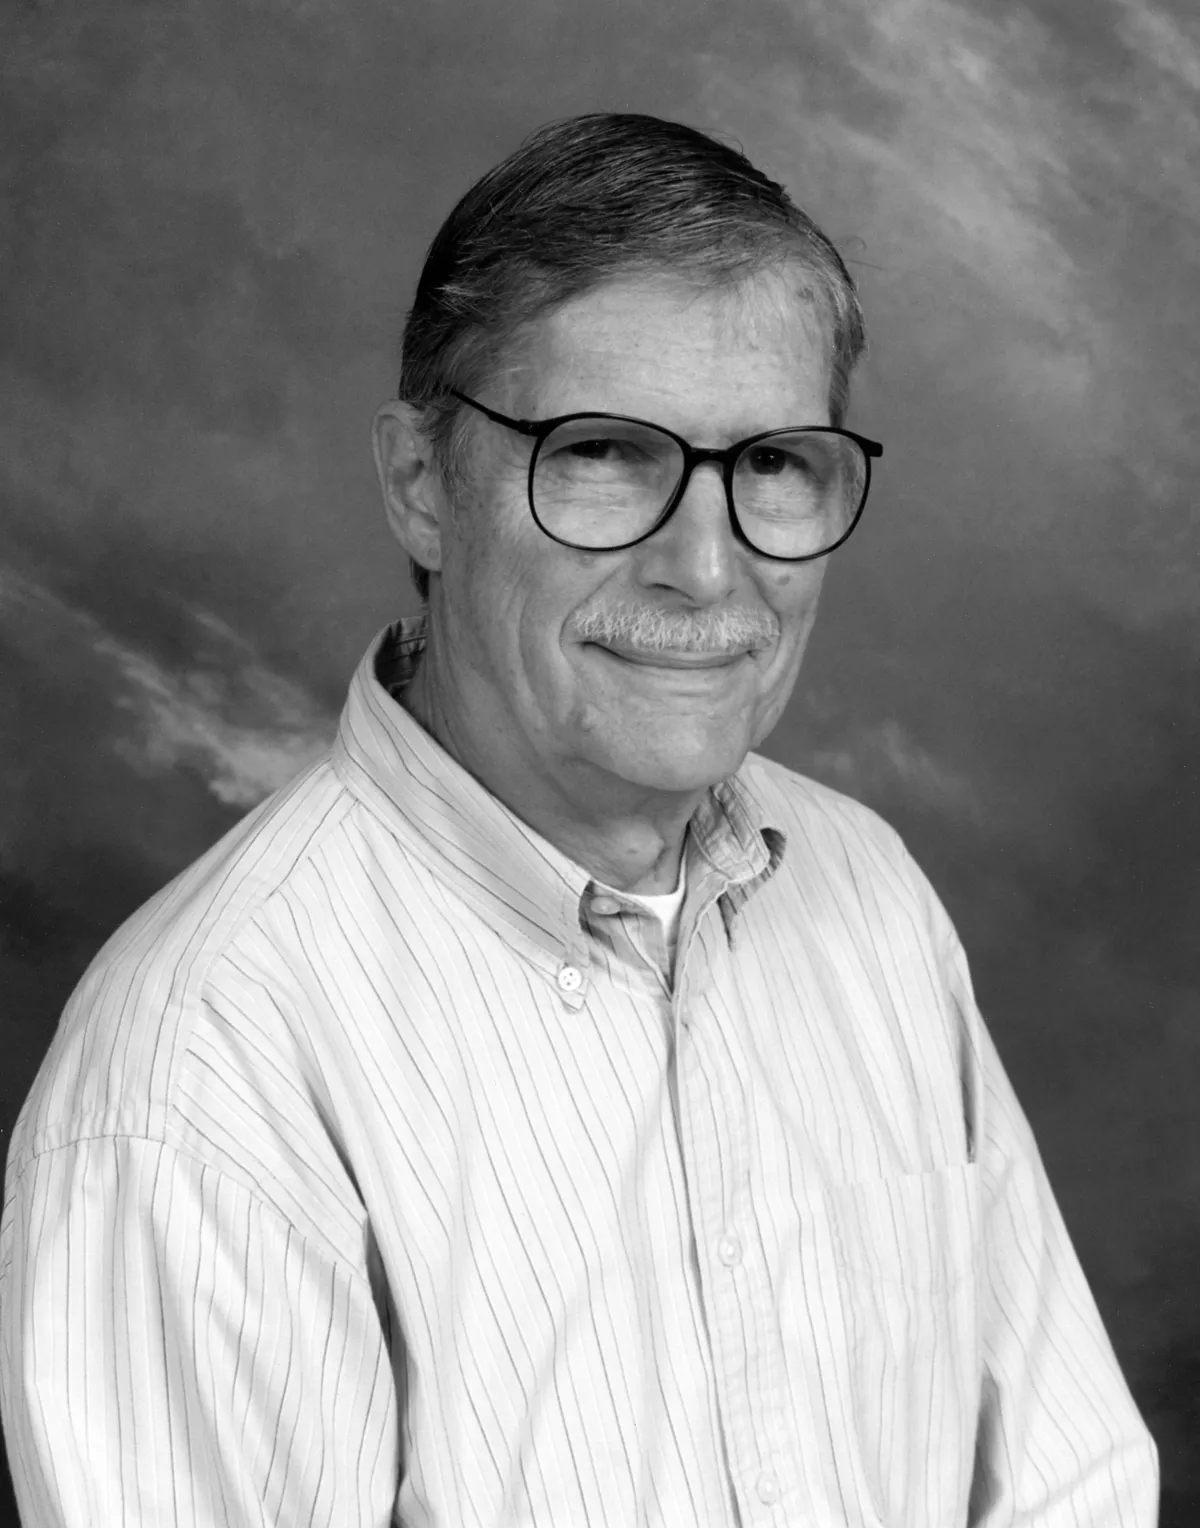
[{"xmin": 0, "ymin": 116, "xmax": 1156, "ymax": 1528}]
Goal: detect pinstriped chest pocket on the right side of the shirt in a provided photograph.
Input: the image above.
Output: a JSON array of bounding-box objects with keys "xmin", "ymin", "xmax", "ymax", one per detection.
[{"xmin": 810, "ymin": 1163, "xmax": 981, "ymax": 1528}]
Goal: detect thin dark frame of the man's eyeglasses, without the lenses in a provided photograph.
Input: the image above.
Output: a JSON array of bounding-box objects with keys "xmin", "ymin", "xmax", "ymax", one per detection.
[{"xmin": 448, "ymin": 387, "xmax": 884, "ymax": 562}]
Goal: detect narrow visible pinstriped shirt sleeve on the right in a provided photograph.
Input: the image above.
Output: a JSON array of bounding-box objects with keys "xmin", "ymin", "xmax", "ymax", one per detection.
[{"xmin": 948, "ymin": 934, "xmax": 1159, "ymax": 1528}]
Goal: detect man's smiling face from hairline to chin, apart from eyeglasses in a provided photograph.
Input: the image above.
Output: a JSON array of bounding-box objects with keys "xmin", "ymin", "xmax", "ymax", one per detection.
[{"xmin": 434, "ymin": 274, "xmax": 830, "ymax": 798}]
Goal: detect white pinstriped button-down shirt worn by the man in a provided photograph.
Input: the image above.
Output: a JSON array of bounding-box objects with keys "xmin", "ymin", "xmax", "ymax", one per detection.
[{"xmin": 0, "ymin": 622, "xmax": 1157, "ymax": 1528}]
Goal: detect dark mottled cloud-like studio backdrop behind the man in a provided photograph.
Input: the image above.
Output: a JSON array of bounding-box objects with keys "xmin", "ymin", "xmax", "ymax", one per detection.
[{"xmin": 0, "ymin": 0, "xmax": 1200, "ymax": 1528}]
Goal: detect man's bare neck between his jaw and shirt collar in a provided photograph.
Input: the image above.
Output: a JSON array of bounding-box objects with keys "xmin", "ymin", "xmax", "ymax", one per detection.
[{"xmin": 401, "ymin": 648, "xmax": 703, "ymax": 895}]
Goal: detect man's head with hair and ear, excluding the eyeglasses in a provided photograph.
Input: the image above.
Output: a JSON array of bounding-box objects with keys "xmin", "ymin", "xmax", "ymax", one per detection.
[{"xmin": 376, "ymin": 116, "xmax": 862, "ymax": 861}]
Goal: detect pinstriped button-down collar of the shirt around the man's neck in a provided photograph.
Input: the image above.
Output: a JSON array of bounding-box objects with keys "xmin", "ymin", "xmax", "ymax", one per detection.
[{"xmin": 333, "ymin": 616, "xmax": 784, "ymax": 967}]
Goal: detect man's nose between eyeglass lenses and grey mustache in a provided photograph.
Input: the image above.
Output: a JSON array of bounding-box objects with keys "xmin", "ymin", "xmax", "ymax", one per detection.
[{"xmin": 637, "ymin": 461, "xmax": 743, "ymax": 605}]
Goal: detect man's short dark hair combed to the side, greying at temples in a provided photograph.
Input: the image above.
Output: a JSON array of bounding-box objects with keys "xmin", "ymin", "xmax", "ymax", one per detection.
[{"xmin": 399, "ymin": 112, "xmax": 864, "ymax": 601}]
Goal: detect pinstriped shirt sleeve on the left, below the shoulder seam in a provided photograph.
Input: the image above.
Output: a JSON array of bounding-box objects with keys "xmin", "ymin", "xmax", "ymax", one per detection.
[{"xmin": 0, "ymin": 1135, "xmax": 399, "ymax": 1528}]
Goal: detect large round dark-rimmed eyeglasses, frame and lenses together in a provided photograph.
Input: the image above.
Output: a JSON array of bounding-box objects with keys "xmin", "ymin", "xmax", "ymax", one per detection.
[{"xmin": 449, "ymin": 388, "xmax": 884, "ymax": 562}]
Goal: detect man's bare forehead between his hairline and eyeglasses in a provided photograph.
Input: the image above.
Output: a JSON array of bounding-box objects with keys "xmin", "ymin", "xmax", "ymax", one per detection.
[{"xmin": 501, "ymin": 269, "xmax": 832, "ymax": 443}]
